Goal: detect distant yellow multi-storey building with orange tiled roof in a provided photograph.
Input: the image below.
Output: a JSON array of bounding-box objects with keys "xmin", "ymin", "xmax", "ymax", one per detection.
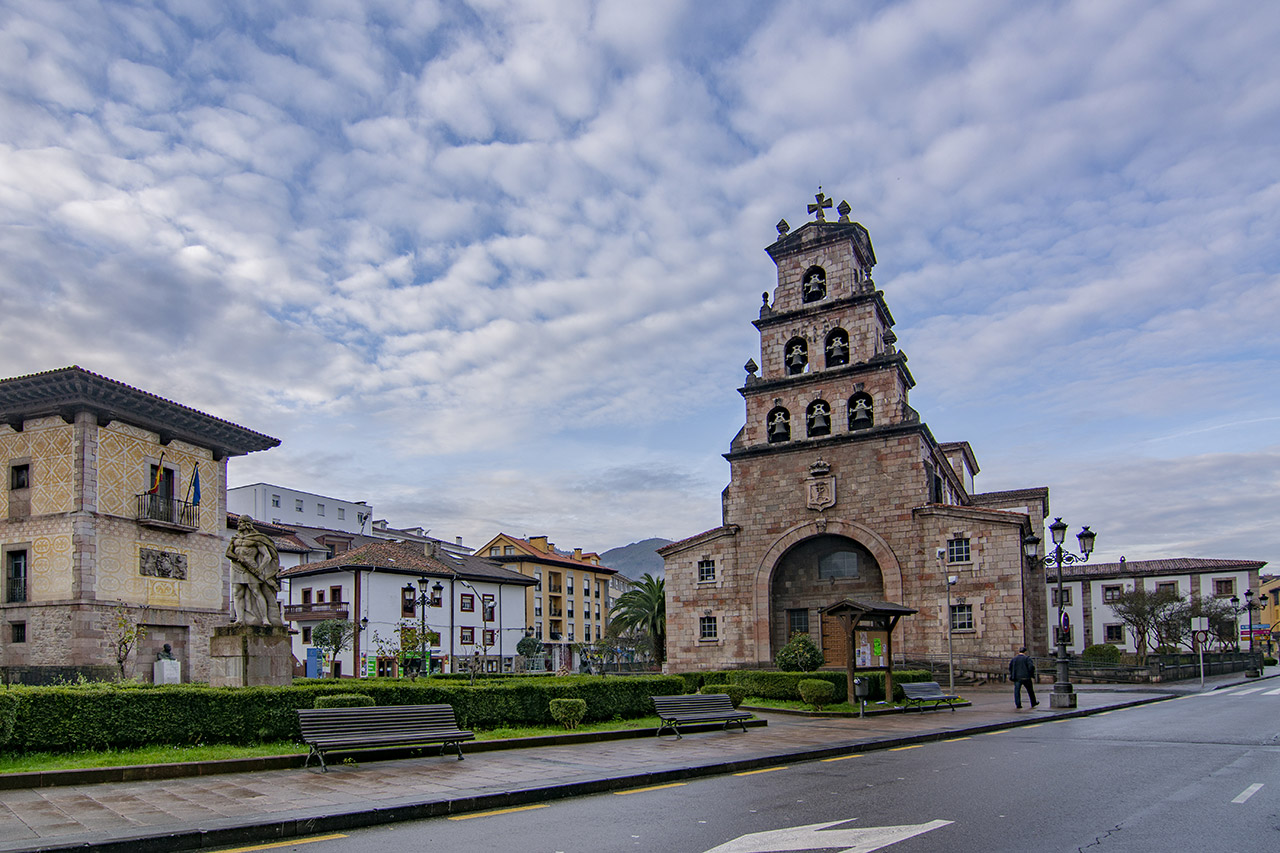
[{"xmin": 475, "ymin": 533, "xmax": 617, "ymax": 670}]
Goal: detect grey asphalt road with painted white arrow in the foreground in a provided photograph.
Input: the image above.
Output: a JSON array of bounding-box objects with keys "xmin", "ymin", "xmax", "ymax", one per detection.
[{"xmin": 230, "ymin": 681, "xmax": 1280, "ymax": 853}]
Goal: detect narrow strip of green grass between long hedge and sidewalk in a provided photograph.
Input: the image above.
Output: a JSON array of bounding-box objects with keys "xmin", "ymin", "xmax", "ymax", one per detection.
[{"xmin": 0, "ymin": 717, "xmax": 658, "ymax": 774}]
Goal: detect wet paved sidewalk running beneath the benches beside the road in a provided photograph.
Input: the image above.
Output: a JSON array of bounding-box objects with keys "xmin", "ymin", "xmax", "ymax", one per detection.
[{"xmin": 0, "ymin": 674, "xmax": 1270, "ymax": 853}]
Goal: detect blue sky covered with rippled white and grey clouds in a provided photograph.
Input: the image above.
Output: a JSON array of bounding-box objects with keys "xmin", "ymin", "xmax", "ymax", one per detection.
[{"xmin": 0, "ymin": 0, "xmax": 1280, "ymax": 565}]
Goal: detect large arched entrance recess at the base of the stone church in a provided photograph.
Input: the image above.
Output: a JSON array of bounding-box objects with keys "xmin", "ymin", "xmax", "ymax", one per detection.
[{"xmin": 769, "ymin": 534, "xmax": 884, "ymax": 662}]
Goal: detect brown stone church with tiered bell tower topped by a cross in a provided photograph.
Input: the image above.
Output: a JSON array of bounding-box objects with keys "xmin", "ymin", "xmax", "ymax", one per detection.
[{"xmin": 659, "ymin": 193, "xmax": 1048, "ymax": 671}]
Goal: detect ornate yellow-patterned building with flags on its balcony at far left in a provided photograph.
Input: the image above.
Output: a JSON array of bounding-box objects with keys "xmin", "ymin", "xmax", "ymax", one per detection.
[{"xmin": 0, "ymin": 368, "xmax": 280, "ymax": 683}]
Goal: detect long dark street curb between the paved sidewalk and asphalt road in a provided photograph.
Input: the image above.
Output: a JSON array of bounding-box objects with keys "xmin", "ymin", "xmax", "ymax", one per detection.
[{"xmin": 0, "ymin": 695, "xmax": 1176, "ymax": 853}]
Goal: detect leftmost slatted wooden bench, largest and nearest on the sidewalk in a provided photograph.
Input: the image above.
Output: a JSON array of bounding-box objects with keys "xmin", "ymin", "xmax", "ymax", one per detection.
[{"xmin": 298, "ymin": 704, "xmax": 475, "ymax": 772}]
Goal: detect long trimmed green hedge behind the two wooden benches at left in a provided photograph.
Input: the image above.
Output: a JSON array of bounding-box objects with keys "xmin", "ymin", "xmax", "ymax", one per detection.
[{"xmin": 0, "ymin": 675, "xmax": 684, "ymax": 751}]
